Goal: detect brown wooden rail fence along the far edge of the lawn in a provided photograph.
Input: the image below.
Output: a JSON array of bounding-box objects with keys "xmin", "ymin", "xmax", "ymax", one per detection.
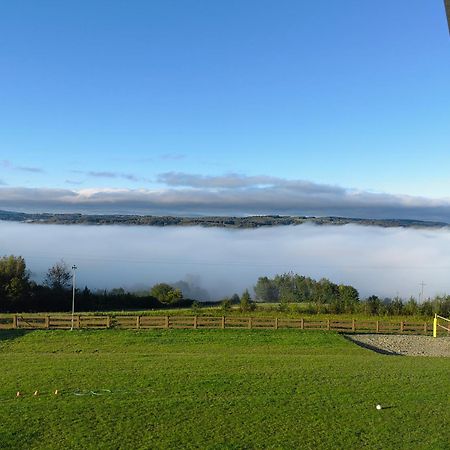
[{"xmin": 0, "ymin": 314, "xmax": 440, "ymax": 335}]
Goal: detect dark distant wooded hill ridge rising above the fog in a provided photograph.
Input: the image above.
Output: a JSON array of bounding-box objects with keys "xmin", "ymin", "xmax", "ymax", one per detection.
[{"xmin": 0, "ymin": 210, "xmax": 449, "ymax": 228}]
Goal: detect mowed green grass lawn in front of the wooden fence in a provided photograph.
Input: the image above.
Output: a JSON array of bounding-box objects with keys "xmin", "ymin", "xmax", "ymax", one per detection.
[{"xmin": 0, "ymin": 330, "xmax": 450, "ymax": 449}]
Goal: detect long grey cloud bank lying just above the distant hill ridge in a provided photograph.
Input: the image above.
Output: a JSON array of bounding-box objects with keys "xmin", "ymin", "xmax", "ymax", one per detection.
[{"xmin": 0, "ymin": 172, "xmax": 450, "ymax": 222}]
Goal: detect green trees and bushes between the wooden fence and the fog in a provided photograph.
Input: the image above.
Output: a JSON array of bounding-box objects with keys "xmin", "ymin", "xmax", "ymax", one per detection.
[{"xmin": 0, "ymin": 255, "xmax": 450, "ymax": 316}]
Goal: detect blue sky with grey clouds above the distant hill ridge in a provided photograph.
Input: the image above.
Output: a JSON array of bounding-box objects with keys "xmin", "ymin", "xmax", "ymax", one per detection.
[{"xmin": 0, "ymin": 0, "xmax": 450, "ymax": 218}]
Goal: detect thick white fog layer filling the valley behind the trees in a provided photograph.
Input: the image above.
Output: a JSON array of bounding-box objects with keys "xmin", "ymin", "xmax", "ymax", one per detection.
[{"xmin": 0, "ymin": 222, "xmax": 450, "ymax": 299}]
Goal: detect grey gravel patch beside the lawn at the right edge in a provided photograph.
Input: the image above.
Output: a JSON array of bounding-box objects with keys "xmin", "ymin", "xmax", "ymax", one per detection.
[{"xmin": 346, "ymin": 334, "xmax": 450, "ymax": 357}]
